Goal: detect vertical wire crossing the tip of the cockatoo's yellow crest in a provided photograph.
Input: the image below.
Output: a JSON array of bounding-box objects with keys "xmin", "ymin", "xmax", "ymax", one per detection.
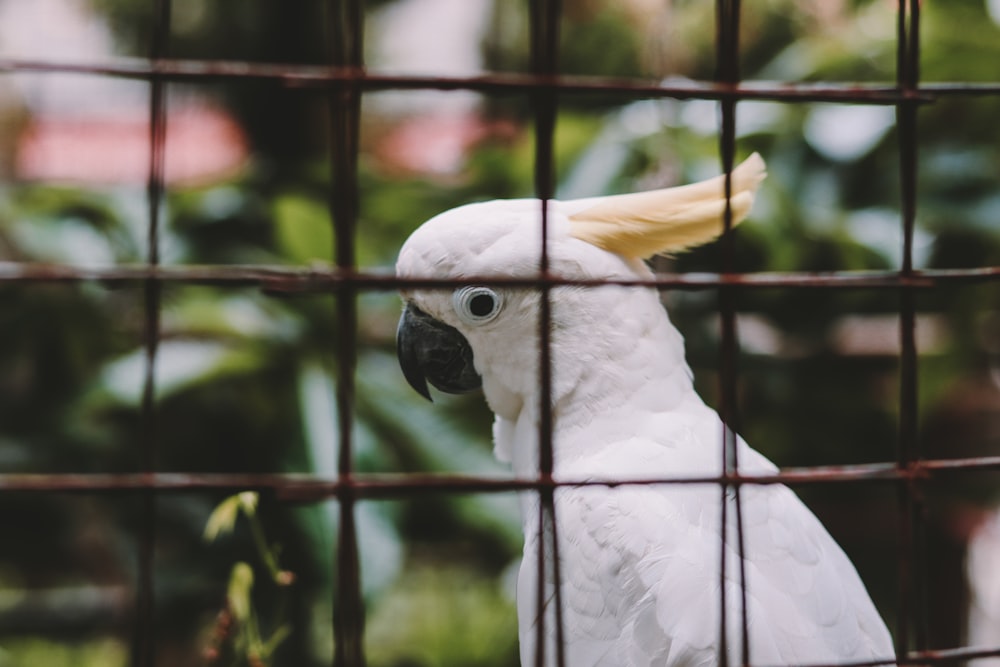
[{"xmin": 716, "ymin": 0, "xmax": 750, "ymax": 667}]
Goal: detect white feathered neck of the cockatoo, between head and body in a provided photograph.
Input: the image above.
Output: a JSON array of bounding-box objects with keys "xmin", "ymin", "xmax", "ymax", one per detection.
[{"xmin": 484, "ymin": 289, "xmax": 700, "ymax": 476}]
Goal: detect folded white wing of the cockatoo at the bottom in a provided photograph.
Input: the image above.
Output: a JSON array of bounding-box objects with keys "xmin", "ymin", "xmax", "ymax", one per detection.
[{"xmin": 519, "ymin": 439, "xmax": 893, "ymax": 667}]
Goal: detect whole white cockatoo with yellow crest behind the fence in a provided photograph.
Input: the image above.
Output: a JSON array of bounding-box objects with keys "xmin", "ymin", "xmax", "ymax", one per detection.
[{"xmin": 396, "ymin": 154, "xmax": 894, "ymax": 667}]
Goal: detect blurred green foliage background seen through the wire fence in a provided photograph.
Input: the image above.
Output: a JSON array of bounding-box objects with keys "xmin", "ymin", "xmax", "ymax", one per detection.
[{"xmin": 0, "ymin": 0, "xmax": 1000, "ymax": 667}]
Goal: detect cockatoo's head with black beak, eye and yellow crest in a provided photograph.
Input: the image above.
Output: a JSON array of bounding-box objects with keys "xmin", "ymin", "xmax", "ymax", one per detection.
[{"xmin": 396, "ymin": 154, "xmax": 765, "ymax": 415}]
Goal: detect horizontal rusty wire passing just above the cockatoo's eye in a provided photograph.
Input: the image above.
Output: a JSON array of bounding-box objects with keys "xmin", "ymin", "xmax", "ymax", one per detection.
[{"xmin": 0, "ymin": 262, "xmax": 1000, "ymax": 293}]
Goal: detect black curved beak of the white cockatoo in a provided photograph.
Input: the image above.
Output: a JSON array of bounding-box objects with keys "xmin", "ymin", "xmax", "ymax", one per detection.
[{"xmin": 396, "ymin": 303, "xmax": 483, "ymax": 401}]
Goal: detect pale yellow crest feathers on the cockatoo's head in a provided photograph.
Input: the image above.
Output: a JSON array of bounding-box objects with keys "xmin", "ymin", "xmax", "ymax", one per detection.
[{"xmin": 569, "ymin": 153, "xmax": 767, "ymax": 259}]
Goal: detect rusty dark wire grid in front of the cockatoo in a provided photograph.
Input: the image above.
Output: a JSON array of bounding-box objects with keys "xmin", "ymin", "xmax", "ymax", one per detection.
[{"xmin": 0, "ymin": 0, "xmax": 1000, "ymax": 667}]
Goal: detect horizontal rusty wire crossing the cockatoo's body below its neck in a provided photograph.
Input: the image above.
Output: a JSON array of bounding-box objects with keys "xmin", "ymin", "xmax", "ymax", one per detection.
[{"xmin": 0, "ymin": 456, "xmax": 1000, "ymax": 502}]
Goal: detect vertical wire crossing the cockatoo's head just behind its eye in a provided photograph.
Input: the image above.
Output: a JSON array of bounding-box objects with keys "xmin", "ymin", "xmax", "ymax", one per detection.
[{"xmin": 531, "ymin": 0, "xmax": 566, "ymax": 667}]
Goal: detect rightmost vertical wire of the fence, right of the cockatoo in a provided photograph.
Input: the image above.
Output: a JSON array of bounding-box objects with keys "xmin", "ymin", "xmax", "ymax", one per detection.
[{"xmin": 896, "ymin": 0, "xmax": 928, "ymax": 655}]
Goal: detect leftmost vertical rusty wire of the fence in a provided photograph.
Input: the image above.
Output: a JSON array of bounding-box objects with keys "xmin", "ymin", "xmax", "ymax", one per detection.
[{"xmin": 131, "ymin": 0, "xmax": 171, "ymax": 667}]
